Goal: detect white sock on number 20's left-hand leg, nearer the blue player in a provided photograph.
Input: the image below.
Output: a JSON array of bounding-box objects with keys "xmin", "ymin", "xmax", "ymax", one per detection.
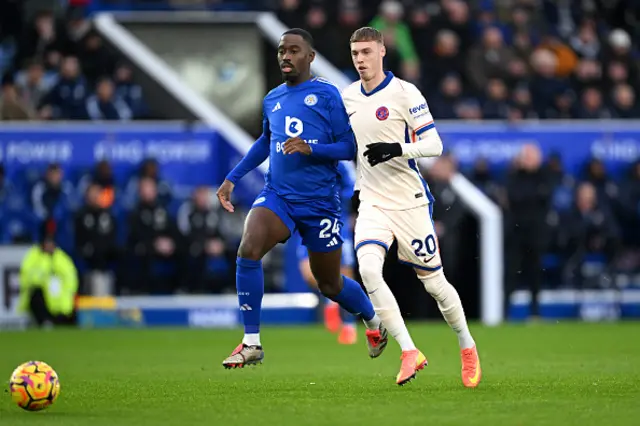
[{"xmin": 358, "ymin": 244, "xmax": 416, "ymax": 351}]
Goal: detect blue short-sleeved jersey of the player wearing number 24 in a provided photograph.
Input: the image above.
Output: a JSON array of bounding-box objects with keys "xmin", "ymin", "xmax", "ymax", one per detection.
[{"xmin": 263, "ymin": 78, "xmax": 355, "ymax": 202}]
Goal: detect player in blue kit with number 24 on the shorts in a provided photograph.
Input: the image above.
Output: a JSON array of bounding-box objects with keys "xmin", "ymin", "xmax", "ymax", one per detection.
[{"xmin": 217, "ymin": 28, "xmax": 388, "ymax": 368}]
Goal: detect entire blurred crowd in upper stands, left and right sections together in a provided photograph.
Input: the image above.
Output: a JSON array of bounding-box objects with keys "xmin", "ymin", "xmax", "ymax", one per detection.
[{"xmin": 0, "ymin": 0, "xmax": 640, "ymax": 120}]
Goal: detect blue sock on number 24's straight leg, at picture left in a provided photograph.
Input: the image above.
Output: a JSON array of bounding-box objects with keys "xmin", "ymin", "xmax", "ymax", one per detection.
[{"xmin": 236, "ymin": 257, "xmax": 264, "ymax": 334}]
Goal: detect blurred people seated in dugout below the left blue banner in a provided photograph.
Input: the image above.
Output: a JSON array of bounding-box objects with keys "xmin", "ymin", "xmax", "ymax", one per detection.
[{"xmin": 0, "ymin": 159, "xmax": 249, "ymax": 295}]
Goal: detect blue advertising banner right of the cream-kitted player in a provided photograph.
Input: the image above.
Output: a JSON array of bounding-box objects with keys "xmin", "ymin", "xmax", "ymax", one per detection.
[{"xmin": 438, "ymin": 121, "xmax": 640, "ymax": 174}]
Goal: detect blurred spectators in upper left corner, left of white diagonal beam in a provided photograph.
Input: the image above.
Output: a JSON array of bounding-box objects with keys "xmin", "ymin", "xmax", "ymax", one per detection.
[{"xmin": 0, "ymin": 0, "xmax": 147, "ymax": 121}]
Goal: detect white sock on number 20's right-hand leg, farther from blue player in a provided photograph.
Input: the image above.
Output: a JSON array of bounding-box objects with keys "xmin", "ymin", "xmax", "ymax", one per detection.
[{"xmin": 418, "ymin": 271, "xmax": 475, "ymax": 349}]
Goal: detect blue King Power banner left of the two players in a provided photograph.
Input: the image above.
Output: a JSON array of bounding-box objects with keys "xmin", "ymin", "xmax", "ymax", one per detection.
[{"xmin": 0, "ymin": 123, "xmax": 222, "ymax": 190}]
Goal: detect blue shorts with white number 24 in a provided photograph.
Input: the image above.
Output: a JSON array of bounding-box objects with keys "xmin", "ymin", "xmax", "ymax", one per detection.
[{"xmin": 251, "ymin": 188, "xmax": 343, "ymax": 253}]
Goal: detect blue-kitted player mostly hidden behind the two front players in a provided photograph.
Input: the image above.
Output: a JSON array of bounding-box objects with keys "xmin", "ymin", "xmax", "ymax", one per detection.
[{"xmin": 297, "ymin": 161, "xmax": 358, "ymax": 345}]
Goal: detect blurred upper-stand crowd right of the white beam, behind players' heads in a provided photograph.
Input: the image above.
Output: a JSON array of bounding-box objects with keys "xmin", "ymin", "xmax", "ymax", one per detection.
[{"xmin": 277, "ymin": 0, "xmax": 640, "ymax": 120}]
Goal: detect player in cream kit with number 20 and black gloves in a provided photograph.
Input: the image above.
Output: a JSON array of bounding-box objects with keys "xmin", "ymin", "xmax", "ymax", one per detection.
[{"xmin": 342, "ymin": 27, "xmax": 482, "ymax": 387}]
